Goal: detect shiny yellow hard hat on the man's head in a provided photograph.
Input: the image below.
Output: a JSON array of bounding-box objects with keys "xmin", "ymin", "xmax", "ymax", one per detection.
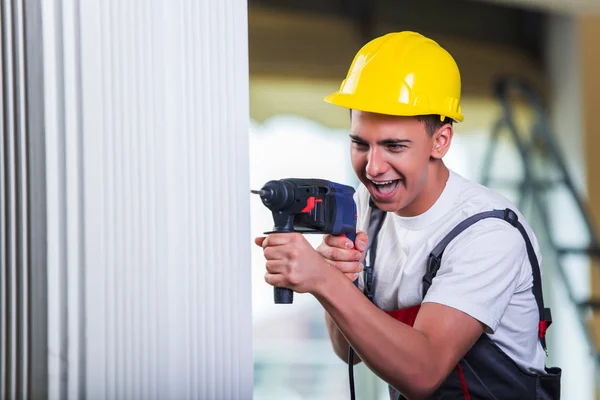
[{"xmin": 325, "ymin": 31, "xmax": 463, "ymax": 121}]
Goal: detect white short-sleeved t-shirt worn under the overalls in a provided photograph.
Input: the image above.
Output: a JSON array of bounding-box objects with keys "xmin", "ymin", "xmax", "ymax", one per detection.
[{"xmin": 355, "ymin": 171, "xmax": 545, "ymax": 372}]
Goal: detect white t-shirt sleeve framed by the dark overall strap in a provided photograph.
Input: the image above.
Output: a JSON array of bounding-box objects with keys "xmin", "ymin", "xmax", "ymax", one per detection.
[{"xmin": 424, "ymin": 209, "xmax": 531, "ymax": 333}]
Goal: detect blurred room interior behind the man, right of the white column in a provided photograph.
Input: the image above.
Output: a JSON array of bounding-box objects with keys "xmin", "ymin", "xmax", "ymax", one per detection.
[{"xmin": 248, "ymin": 0, "xmax": 600, "ymax": 400}]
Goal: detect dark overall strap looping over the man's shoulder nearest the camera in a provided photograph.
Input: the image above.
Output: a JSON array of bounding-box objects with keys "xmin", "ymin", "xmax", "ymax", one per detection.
[{"xmin": 423, "ymin": 208, "xmax": 552, "ymax": 350}]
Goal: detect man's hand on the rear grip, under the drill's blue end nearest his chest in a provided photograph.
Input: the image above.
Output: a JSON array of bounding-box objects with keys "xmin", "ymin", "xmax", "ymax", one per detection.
[{"xmin": 317, "ymin": 231, "xmax": 368, "ymax": 282}]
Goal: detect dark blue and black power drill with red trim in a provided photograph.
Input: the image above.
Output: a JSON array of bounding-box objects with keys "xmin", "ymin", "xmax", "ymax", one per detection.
[{"xmin": 252, "ymin": 178, "xmax": 356, "ymax": 304}]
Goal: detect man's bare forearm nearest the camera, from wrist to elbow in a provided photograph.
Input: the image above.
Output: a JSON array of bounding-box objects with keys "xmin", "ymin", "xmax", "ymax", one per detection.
[{"xmin": 315, "ymin": 270, "xmax": 443, "ymax": 399}]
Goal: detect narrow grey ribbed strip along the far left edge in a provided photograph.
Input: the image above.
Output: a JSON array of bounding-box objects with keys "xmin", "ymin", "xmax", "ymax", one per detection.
[{"xmin": 0, "ymin": 1, "xmax": 30, "ymax": 399}]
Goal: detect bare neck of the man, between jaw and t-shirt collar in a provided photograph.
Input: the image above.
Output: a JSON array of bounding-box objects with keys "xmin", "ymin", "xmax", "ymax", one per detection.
[{"xmin": 396, "ymin": 160, "xmax": 450, "ymax": 217}]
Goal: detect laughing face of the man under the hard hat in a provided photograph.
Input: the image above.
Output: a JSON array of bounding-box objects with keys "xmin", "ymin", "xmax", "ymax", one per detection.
[{"xmin": 350, "ymin": 111, "xmax": 453, "ymax": 216}]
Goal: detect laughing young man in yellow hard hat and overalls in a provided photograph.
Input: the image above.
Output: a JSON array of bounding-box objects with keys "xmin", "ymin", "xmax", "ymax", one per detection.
[{"xmin": 256, "ymin": 32, "xmax": 560, "ymax": 399}]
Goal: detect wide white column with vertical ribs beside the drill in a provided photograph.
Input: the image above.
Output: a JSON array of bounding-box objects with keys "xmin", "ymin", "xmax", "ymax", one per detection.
[{"xmin": 42, "ymin": 0, "xmax": 253, "ymax": 399}]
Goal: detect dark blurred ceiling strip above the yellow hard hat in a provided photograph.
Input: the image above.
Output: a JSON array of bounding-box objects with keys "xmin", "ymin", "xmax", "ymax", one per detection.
[{"xmin": 248, "ymin": 0, "xmax": 548, "ymax": 60}]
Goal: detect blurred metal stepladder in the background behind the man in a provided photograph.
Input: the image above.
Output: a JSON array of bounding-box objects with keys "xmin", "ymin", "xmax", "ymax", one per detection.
[{"xmin": 480, "ymin": 77, "xmax": 600, "ymax": 384}]
